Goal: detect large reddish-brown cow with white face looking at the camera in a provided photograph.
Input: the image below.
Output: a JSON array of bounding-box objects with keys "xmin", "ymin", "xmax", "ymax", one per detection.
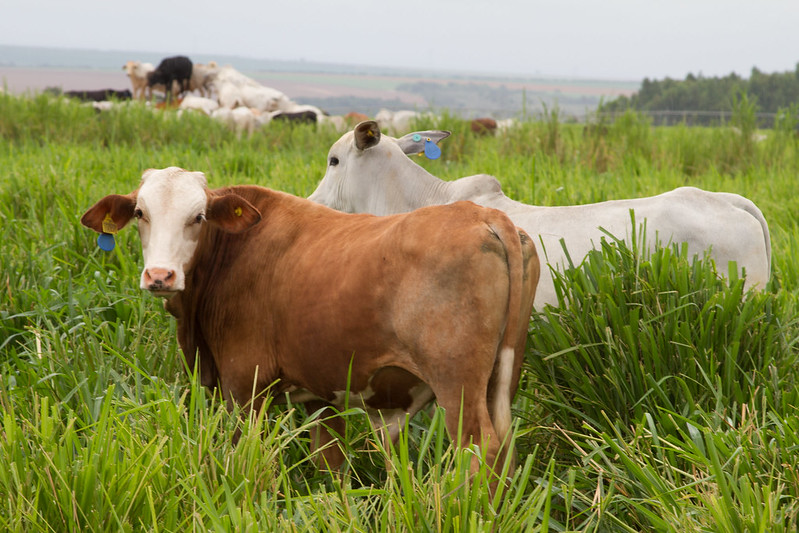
[{"xmin": 81, "ymin": 167, "xmax": 540, "ymax": 478}]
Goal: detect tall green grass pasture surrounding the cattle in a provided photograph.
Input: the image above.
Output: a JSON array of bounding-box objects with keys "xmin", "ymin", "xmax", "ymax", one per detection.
[{"xmin": 0, "ymin": 94, "xmax": 799, "ymax": 532}]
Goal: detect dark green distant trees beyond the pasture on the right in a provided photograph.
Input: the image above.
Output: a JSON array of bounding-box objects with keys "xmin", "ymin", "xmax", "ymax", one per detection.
[{"xmin": 600, "ymin": 64, "xmax": 799, "ymax": 113}]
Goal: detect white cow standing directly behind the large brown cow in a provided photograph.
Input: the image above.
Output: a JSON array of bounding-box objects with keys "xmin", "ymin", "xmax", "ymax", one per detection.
[{"xmin": 308, "ymin": 121, "xmax": 771, "ymax": 310}]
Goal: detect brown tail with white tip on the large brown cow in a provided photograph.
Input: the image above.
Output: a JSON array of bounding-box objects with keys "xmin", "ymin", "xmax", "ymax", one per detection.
[{"xmin": 489, "ymin": 219, "xmax": 539, "ymax": 440}]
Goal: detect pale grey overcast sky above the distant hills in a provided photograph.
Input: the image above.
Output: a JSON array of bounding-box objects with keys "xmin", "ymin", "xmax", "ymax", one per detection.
[{"xmin": 0, "ymin": 0, "xmax": 799, "ymax": 80}]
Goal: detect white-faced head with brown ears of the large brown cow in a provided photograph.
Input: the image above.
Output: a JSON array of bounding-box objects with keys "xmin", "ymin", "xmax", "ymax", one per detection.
[{"xmin": 81, "ymin": 167, "xmax": 261, "ymax": 297}]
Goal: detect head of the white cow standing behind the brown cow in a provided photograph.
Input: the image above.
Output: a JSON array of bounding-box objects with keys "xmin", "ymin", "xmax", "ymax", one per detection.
[{"xmin": 308, "ymin": 120, "xmax": 450, "ymax": 215}]
